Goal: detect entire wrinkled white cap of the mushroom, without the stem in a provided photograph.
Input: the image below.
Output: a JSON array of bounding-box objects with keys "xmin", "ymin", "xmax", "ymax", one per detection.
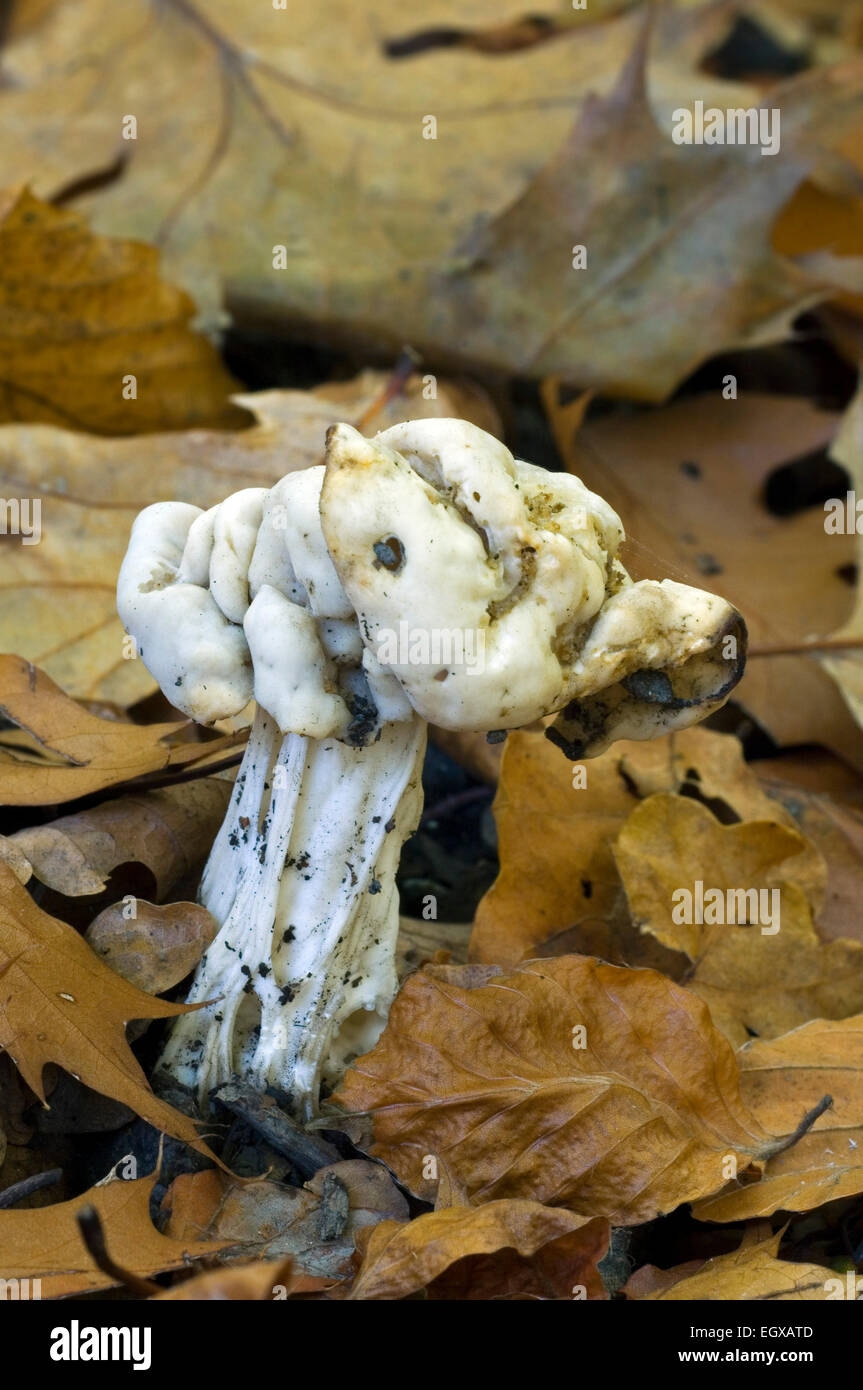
[{"xmin": 117, "ymin": 420, "xmax": 745, "ymax": 756}]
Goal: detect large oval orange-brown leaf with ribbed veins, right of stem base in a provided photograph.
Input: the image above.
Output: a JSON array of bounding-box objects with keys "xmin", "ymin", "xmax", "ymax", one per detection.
[{"xmin": 334, "ymin": 956, "xmax": 770, "ymax": 1226}]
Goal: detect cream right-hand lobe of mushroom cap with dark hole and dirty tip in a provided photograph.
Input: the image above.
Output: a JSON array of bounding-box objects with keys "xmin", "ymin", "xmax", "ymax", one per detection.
[{"xmin": 321, "ymin": 420, "xmax": 745, "ymax": 756}]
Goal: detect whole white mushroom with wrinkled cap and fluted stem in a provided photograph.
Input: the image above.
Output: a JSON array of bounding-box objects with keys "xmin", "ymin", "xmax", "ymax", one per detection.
[{"xmin": 118, "ymin": 420, "xmax": 745, "ymax": 1116}]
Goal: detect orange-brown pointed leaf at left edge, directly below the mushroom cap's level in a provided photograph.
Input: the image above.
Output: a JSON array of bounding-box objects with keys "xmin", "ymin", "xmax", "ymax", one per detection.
[{"xmin": 0, "ymin": 655, "xmax": 238, "ymax": 811}]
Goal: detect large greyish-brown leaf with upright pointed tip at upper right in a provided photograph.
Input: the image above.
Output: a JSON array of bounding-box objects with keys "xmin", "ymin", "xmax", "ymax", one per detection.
[{"xmin": 436, "ymin": 27, "xmax": 863, "ymax": 400}]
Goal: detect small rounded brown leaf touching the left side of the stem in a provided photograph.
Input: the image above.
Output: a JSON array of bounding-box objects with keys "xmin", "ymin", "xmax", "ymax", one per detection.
[{"xmin": 85, "ymin": 898, "xmax": 218, "ymax": 994}]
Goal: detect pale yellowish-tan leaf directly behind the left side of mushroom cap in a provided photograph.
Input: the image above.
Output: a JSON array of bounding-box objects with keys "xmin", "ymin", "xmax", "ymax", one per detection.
[{"xmin": 0, "ymin": 369, "xmax": 500, "ymax": 708}]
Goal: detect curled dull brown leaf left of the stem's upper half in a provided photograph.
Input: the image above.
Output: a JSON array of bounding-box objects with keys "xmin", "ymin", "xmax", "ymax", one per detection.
[{"xmin": 0, "ymin": 778, "xmax": 231, "ymax": 895}]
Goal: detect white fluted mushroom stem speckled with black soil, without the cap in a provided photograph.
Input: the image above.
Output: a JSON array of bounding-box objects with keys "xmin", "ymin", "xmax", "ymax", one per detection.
[{"xmin": 160, "ymin": 708, "xmax": 425, "ymax": 1119}]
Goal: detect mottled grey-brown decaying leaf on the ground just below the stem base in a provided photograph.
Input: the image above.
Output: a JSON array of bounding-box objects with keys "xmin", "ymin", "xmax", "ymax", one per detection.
[{"xmin": 163, "ymin": 1159, "xmax": 409, "ymax": 1280}]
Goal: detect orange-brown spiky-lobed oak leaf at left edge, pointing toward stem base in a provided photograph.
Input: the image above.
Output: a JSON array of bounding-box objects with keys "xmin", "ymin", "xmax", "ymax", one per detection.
[{"xmin": 0, "ymin": 863, "xmax": 211, "ymax": 1156}]
